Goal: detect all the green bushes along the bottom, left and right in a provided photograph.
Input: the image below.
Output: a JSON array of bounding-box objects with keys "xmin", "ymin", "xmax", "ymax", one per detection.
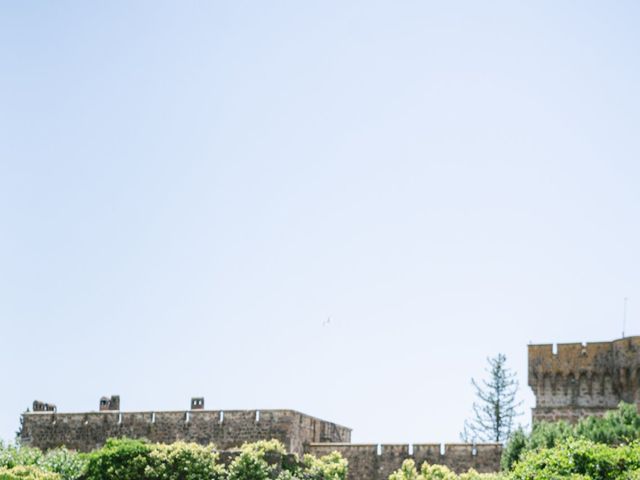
[{"xmin": 7, "ymin": 404, "xmax": 640, "ymax": 480}]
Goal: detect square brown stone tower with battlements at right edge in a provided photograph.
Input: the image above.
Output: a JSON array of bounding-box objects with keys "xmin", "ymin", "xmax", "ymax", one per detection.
[{"xmin": 529, "ymin": 337, "xmax": 640, "ymax": 422}]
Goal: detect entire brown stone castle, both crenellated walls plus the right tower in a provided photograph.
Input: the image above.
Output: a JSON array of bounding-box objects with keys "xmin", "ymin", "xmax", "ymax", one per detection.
[{"xmin": 22, "ymin": 337, "xmax": 640, "ymax": 480}]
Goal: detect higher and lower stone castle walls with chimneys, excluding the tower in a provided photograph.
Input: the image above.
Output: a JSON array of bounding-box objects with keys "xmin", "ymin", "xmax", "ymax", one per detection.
[{"xmin": 21, "ymin": 396, "xmax": 502, "ymax": 480}]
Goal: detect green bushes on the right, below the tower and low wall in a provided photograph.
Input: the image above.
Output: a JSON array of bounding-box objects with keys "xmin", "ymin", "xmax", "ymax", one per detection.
[{"xmin": 389, "ymin": 403, "xmax": 640, "ymax": 480}]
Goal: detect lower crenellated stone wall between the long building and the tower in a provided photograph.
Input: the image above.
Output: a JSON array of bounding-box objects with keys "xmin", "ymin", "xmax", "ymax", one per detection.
[{"xmin": 306, "ymin": 443, "xmax": 502, "ymax": 480}]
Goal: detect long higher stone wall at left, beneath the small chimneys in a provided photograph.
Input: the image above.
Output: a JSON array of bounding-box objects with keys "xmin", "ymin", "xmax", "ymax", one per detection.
[{"xmin": 22, "ymin": 410, "xmax": 351, "ymax": 454}]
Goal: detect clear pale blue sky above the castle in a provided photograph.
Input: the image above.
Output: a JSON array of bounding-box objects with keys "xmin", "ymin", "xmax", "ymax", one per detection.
[{"xmin": 0, "ymin": 0, "xmax": 640, "ymax": 443}]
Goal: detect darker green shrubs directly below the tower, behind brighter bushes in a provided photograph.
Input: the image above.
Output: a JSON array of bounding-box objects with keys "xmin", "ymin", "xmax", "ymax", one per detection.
[{"xmin": 502, "ymin": 403, "xmax": 640, "ymax": 470}]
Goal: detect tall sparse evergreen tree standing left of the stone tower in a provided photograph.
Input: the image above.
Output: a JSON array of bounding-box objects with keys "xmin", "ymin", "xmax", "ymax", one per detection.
[{"xmin": 460, "ymin": 353, "xmax": 522, "ymax": 442}]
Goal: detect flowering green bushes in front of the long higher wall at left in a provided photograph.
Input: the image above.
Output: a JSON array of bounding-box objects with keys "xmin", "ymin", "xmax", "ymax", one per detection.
[{"xmin": 0, "ymin": 439, "xmax": 347, "ymax": 480}]
